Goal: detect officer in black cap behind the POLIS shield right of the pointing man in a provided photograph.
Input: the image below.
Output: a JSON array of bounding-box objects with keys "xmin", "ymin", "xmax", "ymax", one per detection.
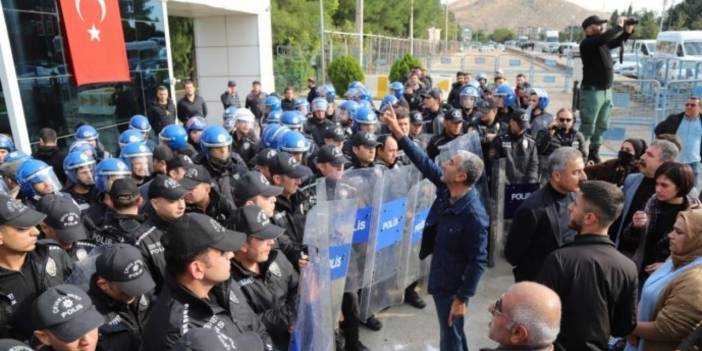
[{"xmin": 489, "ymin": 108, "xmax": 539, "ymax": 184}]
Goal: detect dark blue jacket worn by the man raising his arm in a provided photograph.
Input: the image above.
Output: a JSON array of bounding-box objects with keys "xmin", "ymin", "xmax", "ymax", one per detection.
[{"xmin": 399, "ymin": 137, "xmax": 490, "ymax": 302}]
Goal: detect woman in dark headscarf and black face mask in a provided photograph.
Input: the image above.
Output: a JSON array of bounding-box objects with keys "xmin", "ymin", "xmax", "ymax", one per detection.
[{"xmin": 585, "ymin": 139, "xmax": 646, "ymax": 186}]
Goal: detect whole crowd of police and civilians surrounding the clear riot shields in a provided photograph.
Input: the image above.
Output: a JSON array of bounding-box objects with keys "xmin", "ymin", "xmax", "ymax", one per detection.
[{"xmin": 0, "ymin": 15, "xmax": 702, "ymax": 351}]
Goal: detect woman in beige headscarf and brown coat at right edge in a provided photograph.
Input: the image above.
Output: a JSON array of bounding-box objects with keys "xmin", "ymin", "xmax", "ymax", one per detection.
[{"xmin": 626, "ymin": 205, "xmax": 702, "ymax": 351}]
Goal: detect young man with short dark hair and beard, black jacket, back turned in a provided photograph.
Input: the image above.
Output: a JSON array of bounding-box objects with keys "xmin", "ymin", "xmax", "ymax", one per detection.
[{"xmin": 538, "ymin": 180, "xmax": 638, "ymax": 350}]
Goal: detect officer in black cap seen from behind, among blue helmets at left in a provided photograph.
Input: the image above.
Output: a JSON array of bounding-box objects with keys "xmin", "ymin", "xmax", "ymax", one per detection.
[{"xmin": 92, "ymin": 178, "xmax": 153, "ymax": 246}]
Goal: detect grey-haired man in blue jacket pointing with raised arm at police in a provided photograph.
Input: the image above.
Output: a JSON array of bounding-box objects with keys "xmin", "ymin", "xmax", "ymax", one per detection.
[{"xmin": 384, "ymin": 109, "xmax": 489, "ymax": 351}]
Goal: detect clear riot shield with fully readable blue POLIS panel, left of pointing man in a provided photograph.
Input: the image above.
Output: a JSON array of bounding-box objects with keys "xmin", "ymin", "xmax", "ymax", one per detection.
[{"xmin": 361, "ymin": 166, "xmax": 416, "ymax": 320}]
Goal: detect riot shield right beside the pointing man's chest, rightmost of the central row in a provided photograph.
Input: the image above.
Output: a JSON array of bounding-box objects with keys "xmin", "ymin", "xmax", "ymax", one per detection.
[{"xmin": 400, "ymin": 179, "xmax": 436, "ymax": 287}]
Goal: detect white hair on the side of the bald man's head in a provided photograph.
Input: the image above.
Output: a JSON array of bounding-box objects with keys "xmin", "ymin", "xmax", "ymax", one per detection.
[{"xmin": 510, "ymin": 304, "xmax": 561, "ymax": 347}]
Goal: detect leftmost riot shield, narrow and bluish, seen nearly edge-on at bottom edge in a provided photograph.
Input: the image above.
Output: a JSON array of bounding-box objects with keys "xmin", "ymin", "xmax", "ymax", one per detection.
[{"xmin": 290, "ymin": 206, "xmax": 334, "ymax": 351}]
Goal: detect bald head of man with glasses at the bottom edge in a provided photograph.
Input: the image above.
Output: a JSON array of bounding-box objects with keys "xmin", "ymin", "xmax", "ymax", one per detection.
[{"xmin": 481, "ymin": 282, "xmax": 561, "ymax": 351}]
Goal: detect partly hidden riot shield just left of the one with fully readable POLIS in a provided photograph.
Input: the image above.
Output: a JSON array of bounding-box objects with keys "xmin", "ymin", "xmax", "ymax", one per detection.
[{"xmin": 317, "ymin": 167, "xmax": 383, "ymax": 291}]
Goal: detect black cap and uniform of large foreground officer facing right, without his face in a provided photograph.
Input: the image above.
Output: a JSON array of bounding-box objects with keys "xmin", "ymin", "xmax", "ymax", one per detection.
[{"xmin": 142, "ymin": 213, "xmax": 273, "ymax": 351}]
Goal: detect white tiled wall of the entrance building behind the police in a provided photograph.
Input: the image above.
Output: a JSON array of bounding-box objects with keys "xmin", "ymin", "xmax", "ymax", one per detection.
[{"xmin": 193, "ymin": 1, "xmax": 275, "ymax": 123}]
